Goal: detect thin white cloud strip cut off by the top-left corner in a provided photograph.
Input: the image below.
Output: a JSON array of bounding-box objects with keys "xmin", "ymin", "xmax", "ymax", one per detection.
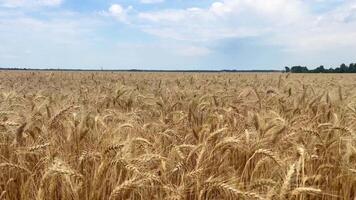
[{"xmin": 0, "ymin": 0, "xmax": 63, "ymax": 8}]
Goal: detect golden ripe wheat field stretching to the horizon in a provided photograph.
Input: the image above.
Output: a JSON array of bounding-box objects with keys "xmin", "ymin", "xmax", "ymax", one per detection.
[{"xmin": 0, "ymin": 71, "xmax": 356, "ymax": 200}]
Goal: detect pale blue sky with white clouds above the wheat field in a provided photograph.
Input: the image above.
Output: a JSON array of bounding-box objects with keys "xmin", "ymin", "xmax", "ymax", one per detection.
[{"xmin": 0, "ymin": 0, "xmax": 356, "ymax": 70}]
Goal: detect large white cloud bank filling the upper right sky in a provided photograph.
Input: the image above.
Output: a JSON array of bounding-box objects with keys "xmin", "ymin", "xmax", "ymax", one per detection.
[{"xmin": 132, "ymin": 0, "xmax": 356, "ymax": 52}]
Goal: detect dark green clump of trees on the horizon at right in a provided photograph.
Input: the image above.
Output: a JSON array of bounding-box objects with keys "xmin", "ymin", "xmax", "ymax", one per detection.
[{"xmin": 285, "ymin": 63, "xmax": 356, "ymax": 73}]
